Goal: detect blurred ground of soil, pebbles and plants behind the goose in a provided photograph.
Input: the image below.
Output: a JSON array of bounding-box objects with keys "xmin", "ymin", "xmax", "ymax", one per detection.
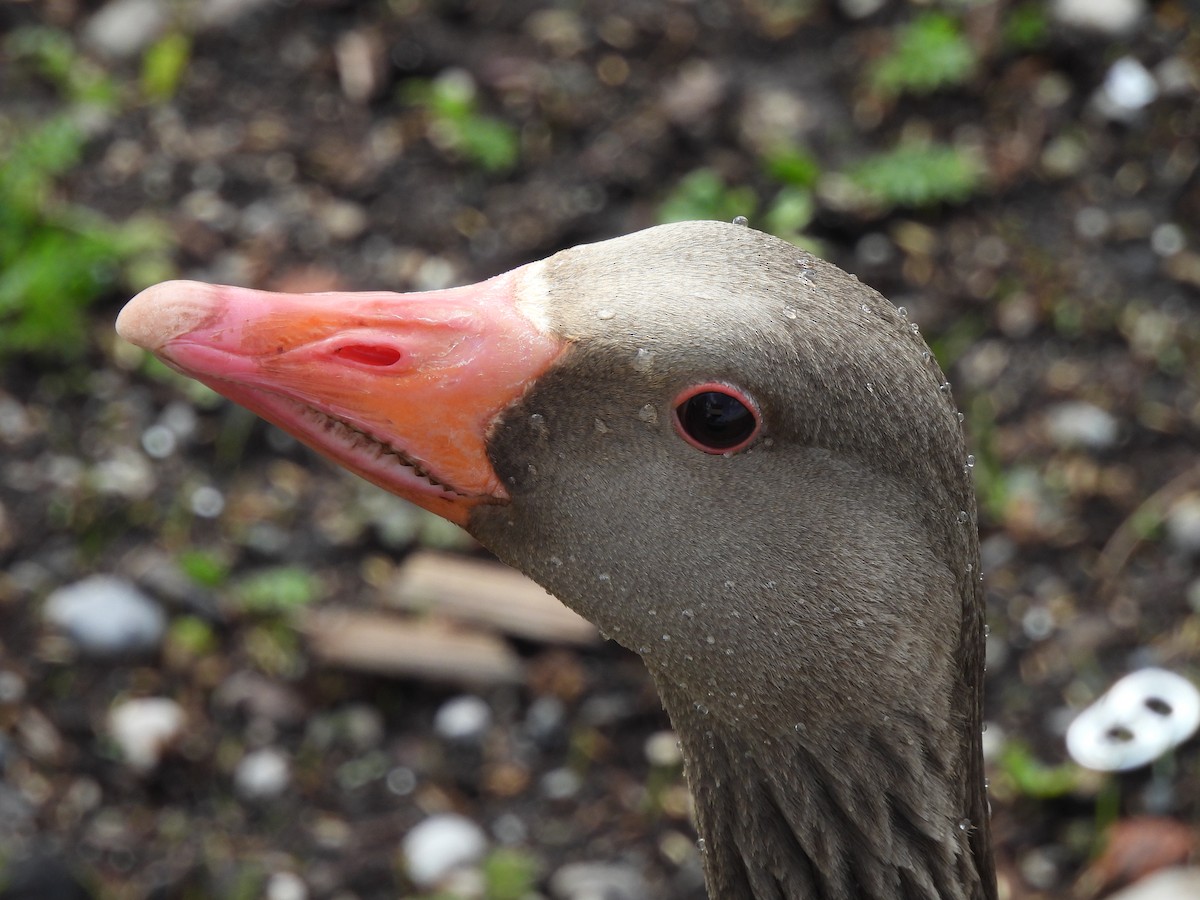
[{"xmin": 0, "ymin": 0, "xmax": 1200, "ymax": 900}]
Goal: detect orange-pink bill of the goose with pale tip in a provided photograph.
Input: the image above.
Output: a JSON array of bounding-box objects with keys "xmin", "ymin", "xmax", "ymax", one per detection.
[{"xmin": 116, "ymin": 269, "xmax": 566, "ymax": 526}]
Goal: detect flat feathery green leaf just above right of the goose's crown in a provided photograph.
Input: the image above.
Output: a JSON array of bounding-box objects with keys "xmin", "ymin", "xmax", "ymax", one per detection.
[{"xmin": 846, "ymin": 139, "xmax": 984, "ymax": 208}]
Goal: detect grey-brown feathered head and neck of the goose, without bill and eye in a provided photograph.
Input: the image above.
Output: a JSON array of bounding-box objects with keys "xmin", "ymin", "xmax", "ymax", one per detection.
[{"xmin": 470, "ymin": 222, "xmax": 995, "ymax": 900}]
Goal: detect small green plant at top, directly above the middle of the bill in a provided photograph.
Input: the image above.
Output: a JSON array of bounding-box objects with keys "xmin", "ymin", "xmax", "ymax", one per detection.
[{"xmin": 403, "ymin": 72, "xmax": 521, "ymax": 172}]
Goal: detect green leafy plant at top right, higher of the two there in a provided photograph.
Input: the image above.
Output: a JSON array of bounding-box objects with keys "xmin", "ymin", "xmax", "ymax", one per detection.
[{"xmin": 870, "ymin": 12, "xmax": 977, "ymax": 96}]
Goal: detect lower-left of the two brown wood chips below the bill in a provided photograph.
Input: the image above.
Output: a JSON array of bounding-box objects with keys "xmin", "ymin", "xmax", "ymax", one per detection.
[{"xmin": 301, "ymin": 608, "xmax": 524, "ymax": 686}]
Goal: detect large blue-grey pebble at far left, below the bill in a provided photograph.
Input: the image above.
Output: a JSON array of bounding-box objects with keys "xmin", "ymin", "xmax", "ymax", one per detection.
[{"xmin": 42, "ymin": 575, "xmax": 167, "ymax": 656}]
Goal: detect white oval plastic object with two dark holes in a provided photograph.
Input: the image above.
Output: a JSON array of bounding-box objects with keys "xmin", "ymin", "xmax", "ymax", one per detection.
[{"xmin": 1067, "ymin": 668, "xmax": 1200, "ymax": 772}]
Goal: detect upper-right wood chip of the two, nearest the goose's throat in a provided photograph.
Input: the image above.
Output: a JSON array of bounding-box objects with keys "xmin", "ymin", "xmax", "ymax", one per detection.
[{"xmin": 388, "ymin": 552, "xmax": 599, "ymax": 644}]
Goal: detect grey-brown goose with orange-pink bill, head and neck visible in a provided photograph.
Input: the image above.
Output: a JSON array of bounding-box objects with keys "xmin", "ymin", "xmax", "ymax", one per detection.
[{"xmin": 118, "ymin": 222, "xmax": 996, "ymax": 900}]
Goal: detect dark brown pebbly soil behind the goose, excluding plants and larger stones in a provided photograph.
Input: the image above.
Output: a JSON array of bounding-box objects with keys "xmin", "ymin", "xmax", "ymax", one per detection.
[{"xmin": 0, "ymin": 0, "xmax": 1200, "ymax": 900}]
